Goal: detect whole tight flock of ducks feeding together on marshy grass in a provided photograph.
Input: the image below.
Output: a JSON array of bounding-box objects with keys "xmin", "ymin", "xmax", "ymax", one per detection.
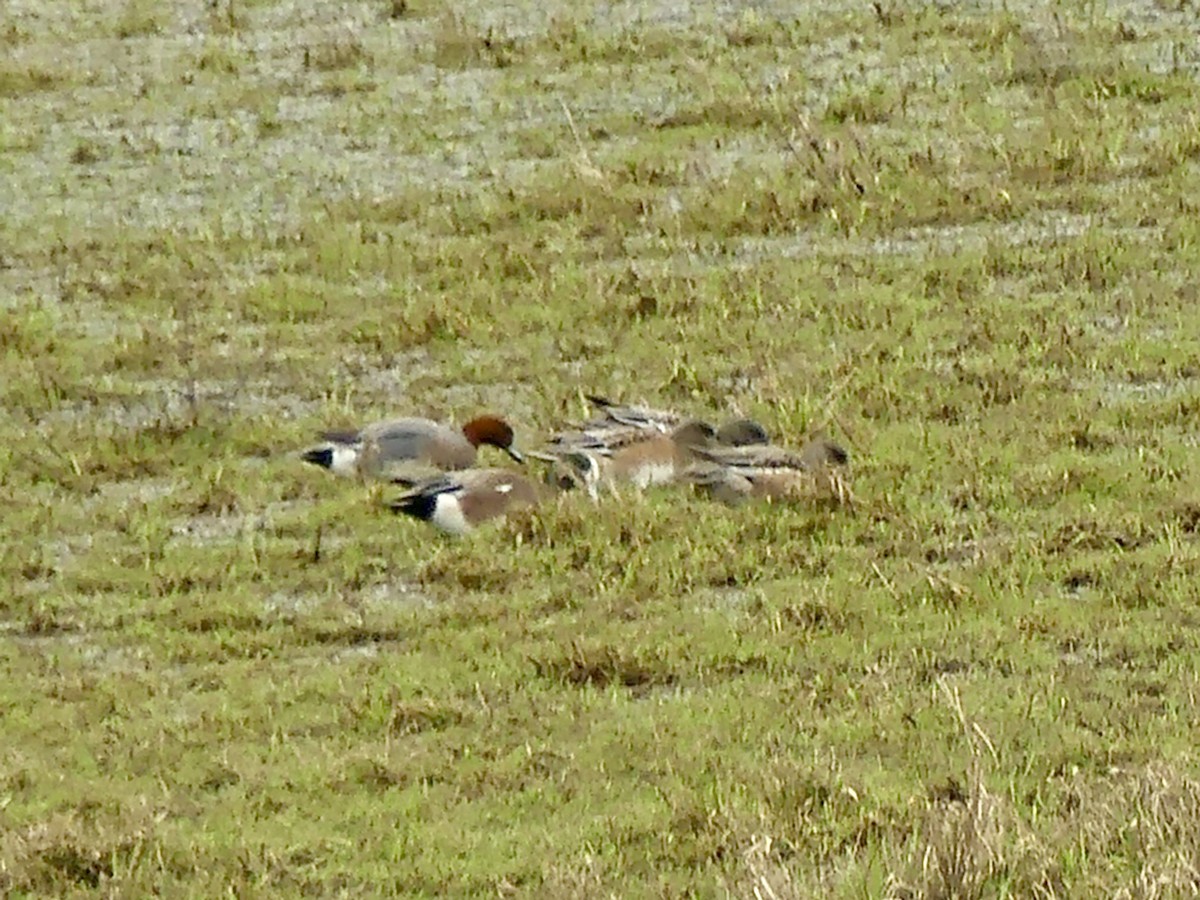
[{"xmin": 301, "ymin": 396, "xmax": 851, "ymax": 534}]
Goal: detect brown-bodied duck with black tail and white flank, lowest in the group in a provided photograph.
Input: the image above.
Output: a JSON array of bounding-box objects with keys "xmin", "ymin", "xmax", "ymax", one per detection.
[{"xmin": 389, "ymin": 469, "xmax": 548, "ymax": 535}]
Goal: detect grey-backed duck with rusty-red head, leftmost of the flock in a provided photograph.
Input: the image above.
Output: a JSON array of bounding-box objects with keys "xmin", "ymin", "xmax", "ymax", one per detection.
[{"xmin": 300, "ymin": 414, "xmax": 524, "ymax": 487}]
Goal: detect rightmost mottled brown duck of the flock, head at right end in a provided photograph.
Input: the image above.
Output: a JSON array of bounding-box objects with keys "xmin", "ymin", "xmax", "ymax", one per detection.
[{"xmin": 679, "ymin": 436, "xmax": 853, "ymax": 506}]
